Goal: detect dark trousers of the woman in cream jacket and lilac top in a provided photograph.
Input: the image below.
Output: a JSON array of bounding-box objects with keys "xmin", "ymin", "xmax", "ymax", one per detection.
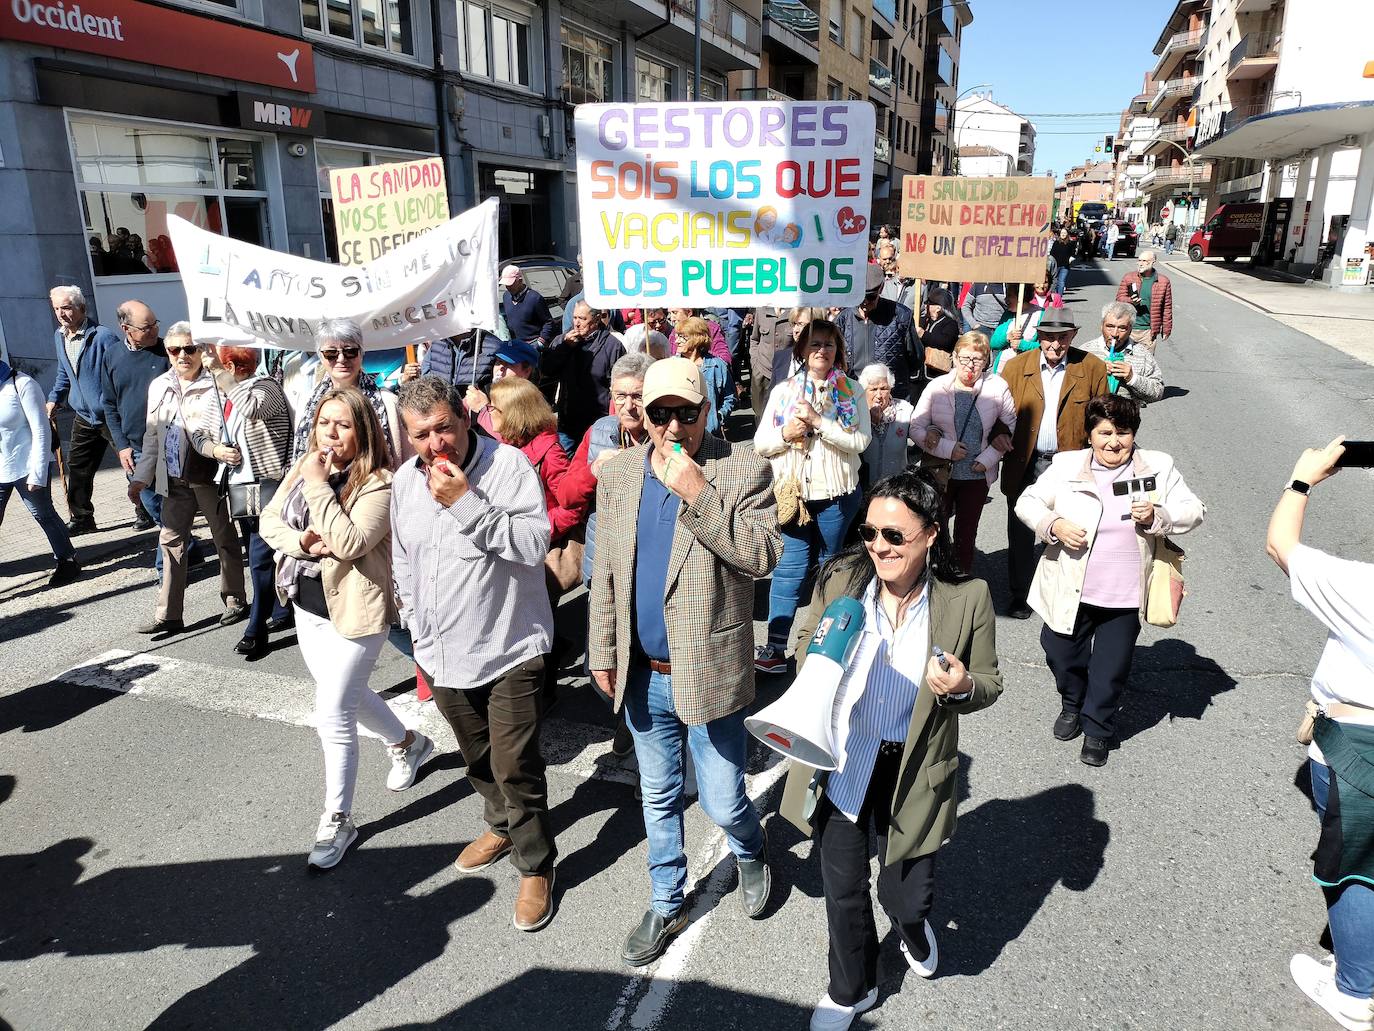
[{"xmin": 1040, "ymin": 605, "xmax": 1140, "ymax": 740}]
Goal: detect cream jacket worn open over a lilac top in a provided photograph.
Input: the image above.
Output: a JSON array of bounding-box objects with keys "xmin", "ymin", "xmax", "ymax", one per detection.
[{"xmin": 1017, "ymin": 448, "xmax": 1206, "ymax": 634}]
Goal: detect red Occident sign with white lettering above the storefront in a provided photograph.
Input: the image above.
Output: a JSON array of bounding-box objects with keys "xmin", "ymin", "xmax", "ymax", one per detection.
[{"xmin": 0, "ymin": 0, "xmax": 315, "ymax": 93}]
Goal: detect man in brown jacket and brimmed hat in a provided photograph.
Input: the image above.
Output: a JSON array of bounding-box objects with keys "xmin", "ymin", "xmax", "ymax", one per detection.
[{"xmin": 995, "ymin": 307, "xmax": 1110, "ymax": 620}]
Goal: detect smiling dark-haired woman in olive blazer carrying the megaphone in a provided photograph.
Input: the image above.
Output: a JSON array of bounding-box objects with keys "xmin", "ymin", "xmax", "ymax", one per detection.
[{"xmin": 782, "ymin": 472, "xmax": 1002, "ymax": 1031}]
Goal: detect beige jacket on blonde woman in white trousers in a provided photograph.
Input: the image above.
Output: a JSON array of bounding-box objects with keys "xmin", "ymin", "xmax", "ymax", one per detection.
[{"xmin": 258, "ymin": 462, "xmax": 396, "ymax": 638}]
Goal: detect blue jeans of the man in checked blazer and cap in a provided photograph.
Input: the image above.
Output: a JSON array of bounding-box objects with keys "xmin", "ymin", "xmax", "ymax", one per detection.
[{"xmin": 625, "ymin": 663, "xmax": 764, "ymax": 917}]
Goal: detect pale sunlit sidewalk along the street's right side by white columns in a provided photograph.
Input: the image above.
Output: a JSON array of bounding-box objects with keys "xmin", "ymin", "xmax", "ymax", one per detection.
[{"xmin": 1161, "ymin": 253, "xmax": 1374, "ymax": 364}]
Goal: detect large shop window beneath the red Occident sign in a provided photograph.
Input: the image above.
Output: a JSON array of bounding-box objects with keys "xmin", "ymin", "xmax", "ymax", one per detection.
[{"xmin": 71, "ymin": 118, "xmax": 272, "ymax": 276}]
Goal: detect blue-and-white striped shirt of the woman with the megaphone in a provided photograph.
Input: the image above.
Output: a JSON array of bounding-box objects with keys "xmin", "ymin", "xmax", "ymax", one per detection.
[{"xmin": 826, "ymin": 579, "xmax": 930, "ymax": 821}]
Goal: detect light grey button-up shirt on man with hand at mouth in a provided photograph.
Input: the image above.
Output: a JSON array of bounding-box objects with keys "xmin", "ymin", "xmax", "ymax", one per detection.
[{"xmin": 392, "ymin": 432, "xmax": 554, "ymax": 690}]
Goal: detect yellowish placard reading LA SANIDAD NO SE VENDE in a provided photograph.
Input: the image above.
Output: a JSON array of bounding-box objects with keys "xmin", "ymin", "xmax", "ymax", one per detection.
[{"xmin": 330, "ymin": 158, "xmax": 448, "ymax": 265}]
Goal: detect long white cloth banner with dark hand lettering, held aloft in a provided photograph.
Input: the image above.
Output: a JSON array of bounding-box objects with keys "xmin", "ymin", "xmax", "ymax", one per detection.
[{"xmin": 168, "ymin": 198, "xmax": 497, "ymax": 351}]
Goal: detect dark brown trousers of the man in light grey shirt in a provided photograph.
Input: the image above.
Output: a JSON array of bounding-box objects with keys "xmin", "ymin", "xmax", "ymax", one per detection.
[{"xmin": 426, "ymin": 656, "xmax": 558, "ymax": 874}]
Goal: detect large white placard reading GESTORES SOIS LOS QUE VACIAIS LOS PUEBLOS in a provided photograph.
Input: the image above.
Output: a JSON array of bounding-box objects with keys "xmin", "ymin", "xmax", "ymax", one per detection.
[{"xmin": 574, "ymin": 100, "xmax": 874, "ymax": 308}]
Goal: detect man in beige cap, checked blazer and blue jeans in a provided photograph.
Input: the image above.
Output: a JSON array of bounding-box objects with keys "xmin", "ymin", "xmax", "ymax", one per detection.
[{"xmin": 587, "ymin": 357, "xmax": 782, "ymax": 966}]
